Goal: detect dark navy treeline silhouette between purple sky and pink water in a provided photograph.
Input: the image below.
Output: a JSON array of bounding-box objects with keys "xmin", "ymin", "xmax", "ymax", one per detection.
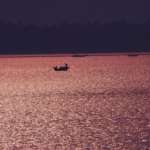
[{"xmin": 0, "ymin": 21, "xmax": 150, "ymax": 54}]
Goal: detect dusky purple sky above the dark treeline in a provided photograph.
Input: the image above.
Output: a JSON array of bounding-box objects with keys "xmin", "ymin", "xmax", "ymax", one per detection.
[{"xmin": 0, "ymin": 0, "xmax": 150, "ymax": 24}]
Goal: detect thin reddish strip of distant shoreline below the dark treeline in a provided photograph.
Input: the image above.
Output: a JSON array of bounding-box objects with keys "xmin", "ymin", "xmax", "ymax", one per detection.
[{"xmin": 0, "ymin": 52, "xmax": 150, "ymax": 58}]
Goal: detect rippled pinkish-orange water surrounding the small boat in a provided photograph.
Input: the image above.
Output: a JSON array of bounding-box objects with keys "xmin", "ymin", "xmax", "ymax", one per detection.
[{"xmin": 0, "ymin": 55, "xmax": 150, "ymax": 150}]
